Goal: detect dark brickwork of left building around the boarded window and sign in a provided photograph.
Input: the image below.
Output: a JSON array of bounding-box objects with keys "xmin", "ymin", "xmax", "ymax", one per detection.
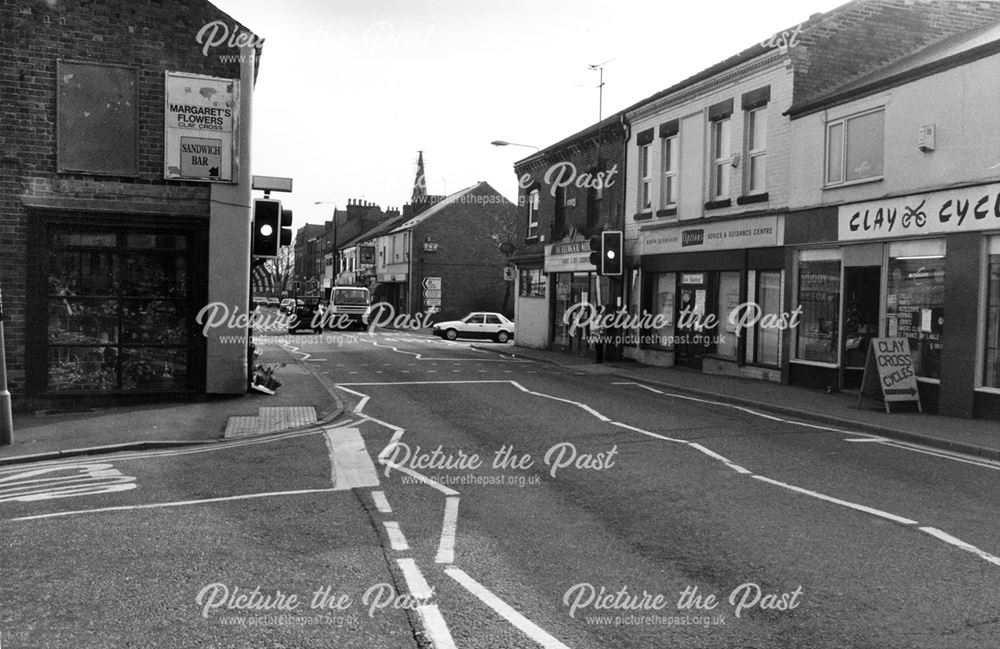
[{"xmin": 0, "ymin": 0, "xmax": 262, "ymax": 400}]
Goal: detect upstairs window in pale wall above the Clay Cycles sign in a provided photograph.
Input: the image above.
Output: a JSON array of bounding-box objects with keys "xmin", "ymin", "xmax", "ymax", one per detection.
[{"xmin": 826, "ymin": 108, "xmax": 885, "ymax": 186}]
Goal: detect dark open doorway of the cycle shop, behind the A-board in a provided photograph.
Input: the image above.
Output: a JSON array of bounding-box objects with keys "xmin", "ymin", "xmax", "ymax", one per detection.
[{"xmin": 841, "ymin": 266, "xmax": 882, "ymax": 389}]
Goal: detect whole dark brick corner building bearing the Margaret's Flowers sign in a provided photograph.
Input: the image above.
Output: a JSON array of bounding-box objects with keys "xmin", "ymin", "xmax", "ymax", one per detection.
[{"xmin": 0, "ymin": 0, "xmax": 262, "ymax": 408}]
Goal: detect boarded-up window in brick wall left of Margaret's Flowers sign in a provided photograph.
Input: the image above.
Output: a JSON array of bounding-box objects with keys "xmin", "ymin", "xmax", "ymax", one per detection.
[{"xmin": 56, "ymin": 61, "xmax": 139, "ymax": 176}]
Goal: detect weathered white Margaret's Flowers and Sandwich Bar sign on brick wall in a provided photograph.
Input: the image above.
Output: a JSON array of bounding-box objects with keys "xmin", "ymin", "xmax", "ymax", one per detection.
[{"xmin": 163, "ymin": 71, "xmax": 239, "ymax": 182}]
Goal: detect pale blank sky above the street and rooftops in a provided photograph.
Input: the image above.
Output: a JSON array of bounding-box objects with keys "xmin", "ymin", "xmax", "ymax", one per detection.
[{"xmin": 213, "ymin": 0, "xmax": 845, "ymax": 228}]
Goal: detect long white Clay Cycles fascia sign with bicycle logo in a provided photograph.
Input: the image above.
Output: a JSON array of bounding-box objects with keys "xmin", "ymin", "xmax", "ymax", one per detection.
[{"xmin": 838, "ymin": 184, "xmax": 1000, "ymax": 241}]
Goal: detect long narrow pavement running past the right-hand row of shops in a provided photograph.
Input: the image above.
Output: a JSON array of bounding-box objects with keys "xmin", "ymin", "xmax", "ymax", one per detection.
[{"xmin": 475, "ymin": 343, "xmax": 1000, "ymax": 460}]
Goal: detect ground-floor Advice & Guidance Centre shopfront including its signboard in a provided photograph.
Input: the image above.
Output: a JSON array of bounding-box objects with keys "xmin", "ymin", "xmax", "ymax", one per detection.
[{"xmin": 626, "ymin": 215, "xmax": 785, "ymax": 381}]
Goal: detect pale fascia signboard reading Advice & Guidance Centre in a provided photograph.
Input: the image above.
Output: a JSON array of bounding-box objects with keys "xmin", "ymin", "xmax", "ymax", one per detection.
[{"xmin": 639, "ymin": 215, "xmax": 785, "ymax": 255}]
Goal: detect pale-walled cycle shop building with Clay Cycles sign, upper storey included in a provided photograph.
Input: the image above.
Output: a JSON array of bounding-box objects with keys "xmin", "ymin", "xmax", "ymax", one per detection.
[{"xmin": 786, "ymin": 23, "xmax": 1000, "ymax": 418}]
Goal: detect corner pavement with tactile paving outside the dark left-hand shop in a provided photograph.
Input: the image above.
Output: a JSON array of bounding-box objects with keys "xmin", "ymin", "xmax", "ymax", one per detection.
[{"xmin": 0, "ymin": 346, "xmax": 342, "ymax": 465}]
